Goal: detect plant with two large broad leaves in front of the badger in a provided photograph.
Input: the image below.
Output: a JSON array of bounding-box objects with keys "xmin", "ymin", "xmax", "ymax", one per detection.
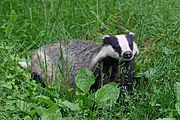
[{"xmin": 76, "ymin": 69, "xmax": 120, "ymax": 109}]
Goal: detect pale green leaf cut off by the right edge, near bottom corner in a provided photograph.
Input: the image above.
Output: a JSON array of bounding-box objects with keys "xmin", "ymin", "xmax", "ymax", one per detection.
[{"xmin": 175, "ymin": 82, "xmax": 180, "ymax": 115}]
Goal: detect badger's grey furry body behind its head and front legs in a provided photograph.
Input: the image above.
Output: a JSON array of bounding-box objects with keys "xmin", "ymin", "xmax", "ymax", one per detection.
[{"xmin": 32, "ymin": 40, "xmax": 100, "ymax": 86}]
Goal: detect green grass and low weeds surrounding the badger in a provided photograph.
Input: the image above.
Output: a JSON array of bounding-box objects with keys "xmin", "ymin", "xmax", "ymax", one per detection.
[{"xmin": 0, "ymin": 0, "xmax": 180, "ymax": 120}]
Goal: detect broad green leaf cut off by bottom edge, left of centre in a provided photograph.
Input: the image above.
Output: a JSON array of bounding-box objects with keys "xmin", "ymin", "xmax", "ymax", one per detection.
[{"xmin": 41, "ymin": 105, "xmax": 62, "ymax": 120}]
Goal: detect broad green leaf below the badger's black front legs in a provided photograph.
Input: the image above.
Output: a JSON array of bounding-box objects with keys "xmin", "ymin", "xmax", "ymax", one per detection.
[{"xmin": 95, "ymin": 83, "xmax": 119, "ymax": 103}]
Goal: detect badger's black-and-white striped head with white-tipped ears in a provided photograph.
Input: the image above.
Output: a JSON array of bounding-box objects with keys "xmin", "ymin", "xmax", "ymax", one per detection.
[{"xmin": 100, "ymin": 32, "xmax": 139, "ymax": 61}]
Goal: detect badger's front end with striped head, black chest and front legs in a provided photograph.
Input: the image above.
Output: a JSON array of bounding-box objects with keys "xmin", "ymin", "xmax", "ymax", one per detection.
[{"xmin": 92, "ymin": 32, "xmax": 139, "ymax": 92}]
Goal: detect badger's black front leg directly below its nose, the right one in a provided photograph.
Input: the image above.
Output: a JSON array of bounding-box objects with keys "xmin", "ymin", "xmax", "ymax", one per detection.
[{"xmin": 121, "ymin": 59, "xmax": 135, "ymax": 94}]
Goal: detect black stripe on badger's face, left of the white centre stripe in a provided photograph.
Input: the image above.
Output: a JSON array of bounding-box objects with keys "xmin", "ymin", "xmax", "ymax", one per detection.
[{"xmin": 104, "ymin": 36, "xmax": 122, "ymax": 54}]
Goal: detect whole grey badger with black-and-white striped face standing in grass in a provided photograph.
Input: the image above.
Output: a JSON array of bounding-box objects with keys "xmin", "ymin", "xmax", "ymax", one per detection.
[{"xmin": 19, "ymin": 32, "xmax": 139, "ymax": 91}]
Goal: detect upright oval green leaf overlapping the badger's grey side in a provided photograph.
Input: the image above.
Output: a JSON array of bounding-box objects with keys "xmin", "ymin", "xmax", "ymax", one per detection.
[{"xmin": 76, "ymin": 68, "xmax": 95, "ymax": 93}]
